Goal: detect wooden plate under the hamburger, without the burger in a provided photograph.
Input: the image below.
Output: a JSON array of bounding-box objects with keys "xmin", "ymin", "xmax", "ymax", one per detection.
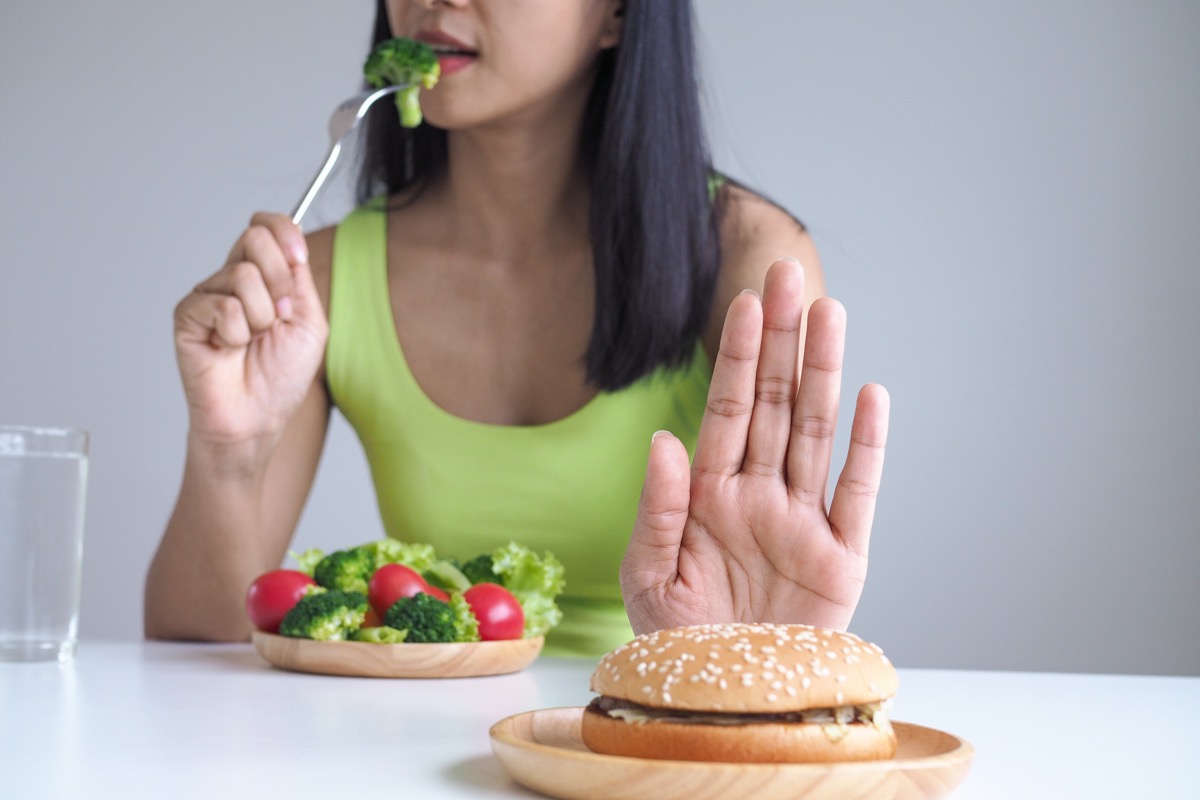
[{"xmin": 491, "ymin": 708, "xmax": 974, "ymax": 800}]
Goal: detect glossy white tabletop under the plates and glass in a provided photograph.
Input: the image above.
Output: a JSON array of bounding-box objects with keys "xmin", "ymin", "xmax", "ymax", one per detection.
[{"xmin": 0, "ymin": 642, "xmax": 1200, "ymax": 800}]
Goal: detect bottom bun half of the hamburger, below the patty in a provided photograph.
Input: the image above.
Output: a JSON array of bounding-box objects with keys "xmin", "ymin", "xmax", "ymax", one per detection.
[{"xmin": 582, "ymin": 708, "xmax": 896, "ymax": 764}]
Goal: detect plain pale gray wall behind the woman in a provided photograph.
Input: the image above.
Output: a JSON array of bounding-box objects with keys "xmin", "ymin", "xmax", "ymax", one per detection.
[{"xmin": 0, "ymin": 0, "xmax": 1200, "ymax": 675}]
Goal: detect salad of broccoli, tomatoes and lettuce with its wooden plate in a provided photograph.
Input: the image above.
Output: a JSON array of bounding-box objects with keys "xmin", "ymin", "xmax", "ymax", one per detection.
[{"xmin": 246, "ymin": 540, "xmax": 564, "ymax": 678}]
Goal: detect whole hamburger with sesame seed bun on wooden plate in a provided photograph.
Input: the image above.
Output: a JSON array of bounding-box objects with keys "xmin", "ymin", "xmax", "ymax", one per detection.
[{"xmin": 582, "ymin": 624, "xmax": 898, "ymax": 763}]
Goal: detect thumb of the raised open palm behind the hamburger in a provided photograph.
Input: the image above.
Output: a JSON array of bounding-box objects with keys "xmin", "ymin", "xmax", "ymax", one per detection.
[{"xmin": 620, "ymin": 431, "xmax": 691, "ymax": 596}]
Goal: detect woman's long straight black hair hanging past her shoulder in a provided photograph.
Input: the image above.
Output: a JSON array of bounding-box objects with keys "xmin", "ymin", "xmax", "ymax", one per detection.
[{"xmin": 358, "ymin": 0, "xmax": 720, "ymax": 391}]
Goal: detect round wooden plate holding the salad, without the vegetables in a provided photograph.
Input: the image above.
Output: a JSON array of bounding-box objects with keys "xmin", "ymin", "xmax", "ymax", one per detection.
[{"xmin": 253, "ymin": 631, "xmax": 545, "ymax": 678}]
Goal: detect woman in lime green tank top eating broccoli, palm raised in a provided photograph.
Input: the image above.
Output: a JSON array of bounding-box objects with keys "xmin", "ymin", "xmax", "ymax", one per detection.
[{"xmin": 145, "ymin": 0, "xmax": 887, "ymax": 655}]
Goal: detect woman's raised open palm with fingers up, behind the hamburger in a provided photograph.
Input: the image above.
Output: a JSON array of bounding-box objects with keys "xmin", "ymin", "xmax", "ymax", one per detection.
[{"xmin": 620, "ymin": 260, "xmax": 888, "ymax": 633}]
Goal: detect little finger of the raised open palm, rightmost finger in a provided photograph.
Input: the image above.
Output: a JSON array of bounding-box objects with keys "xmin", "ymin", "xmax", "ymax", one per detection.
[{"xmin": 829, "ymin": 384, "xmax": 892, "ymax": 555}]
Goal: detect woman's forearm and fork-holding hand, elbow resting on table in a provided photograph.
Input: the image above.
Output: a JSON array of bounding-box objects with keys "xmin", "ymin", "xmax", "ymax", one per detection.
[{"xmin": 144, "ymin": 215, "xmax": 330, "ymax": 640}]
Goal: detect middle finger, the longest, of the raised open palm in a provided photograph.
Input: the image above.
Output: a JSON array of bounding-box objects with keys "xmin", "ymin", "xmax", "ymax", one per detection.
[{"xmin": 742, "ymin": 259, "xmax": 804, "ymax": 476}]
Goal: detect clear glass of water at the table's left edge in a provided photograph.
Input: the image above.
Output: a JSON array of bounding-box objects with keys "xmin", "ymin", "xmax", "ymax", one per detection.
[{"xmin": 0, "ymin": 425, "xmax": 88, "ymax": 662}]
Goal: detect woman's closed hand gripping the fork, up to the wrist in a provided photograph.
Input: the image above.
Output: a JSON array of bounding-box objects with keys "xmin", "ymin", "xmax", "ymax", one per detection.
[{"xmin": 175, "ymin": 213, "xmax": 329, "ymax": 455}]
